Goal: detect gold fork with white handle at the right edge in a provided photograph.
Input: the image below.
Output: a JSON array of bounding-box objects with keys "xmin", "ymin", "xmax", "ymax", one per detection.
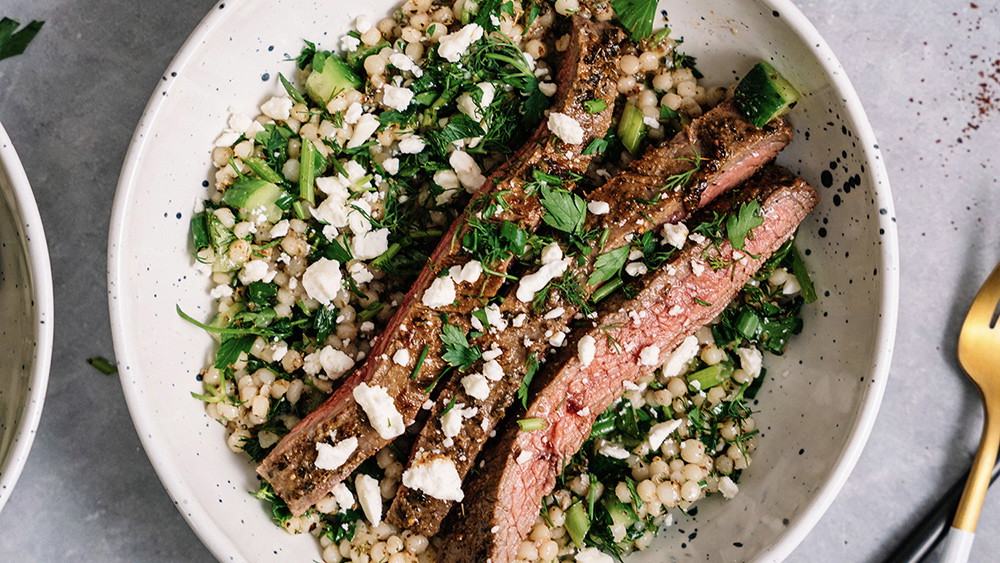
[{"xmin": 941, "ymin": 264, "xmax": 1000, "ymax": 563}]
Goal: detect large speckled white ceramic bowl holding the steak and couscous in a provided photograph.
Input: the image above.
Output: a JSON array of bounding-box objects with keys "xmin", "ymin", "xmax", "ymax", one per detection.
[{"xmin": 109, "ymin": 0, "xmax": 898, "ymax": 561}]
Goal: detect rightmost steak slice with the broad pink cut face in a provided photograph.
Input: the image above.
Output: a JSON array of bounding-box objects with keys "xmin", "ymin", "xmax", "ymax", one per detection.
[{"xmin": 442, "ymin": 167, "xmax": 818, "ymax": 563}]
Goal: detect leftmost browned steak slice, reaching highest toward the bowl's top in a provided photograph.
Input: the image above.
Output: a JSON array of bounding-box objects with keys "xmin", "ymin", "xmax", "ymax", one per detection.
[{"xmin": 257, "ymin": 17, "xmax": 625, "ymax": 515}]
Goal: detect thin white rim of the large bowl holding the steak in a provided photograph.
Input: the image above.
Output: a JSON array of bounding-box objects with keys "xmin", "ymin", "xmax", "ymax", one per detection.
[{"xmin": 108, "ymin": 0, "xmax": 899, "ymax": 561}]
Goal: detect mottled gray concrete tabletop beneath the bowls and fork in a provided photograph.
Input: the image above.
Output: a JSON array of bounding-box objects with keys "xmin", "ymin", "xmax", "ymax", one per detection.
[{"xmin": 0, "ymin": 0, "xmax": 1000, "ymax": 562}]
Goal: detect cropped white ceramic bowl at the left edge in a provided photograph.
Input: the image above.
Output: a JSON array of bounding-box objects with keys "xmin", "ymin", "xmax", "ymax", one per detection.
[{"xmin": 0, "ymin": 121, "xmax": 53, "ymax": 508}]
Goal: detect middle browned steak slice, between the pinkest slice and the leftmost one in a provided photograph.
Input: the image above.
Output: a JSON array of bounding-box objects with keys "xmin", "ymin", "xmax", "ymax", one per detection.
[{"xmin": 387, "ymin": 101, "xmax": 792, "ymax": 536}]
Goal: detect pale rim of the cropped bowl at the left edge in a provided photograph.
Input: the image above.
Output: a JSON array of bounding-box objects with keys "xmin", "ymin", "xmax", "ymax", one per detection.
[{"xmin": 0, "ymin": 124, "xmax": 54, "ymax": 509}]
